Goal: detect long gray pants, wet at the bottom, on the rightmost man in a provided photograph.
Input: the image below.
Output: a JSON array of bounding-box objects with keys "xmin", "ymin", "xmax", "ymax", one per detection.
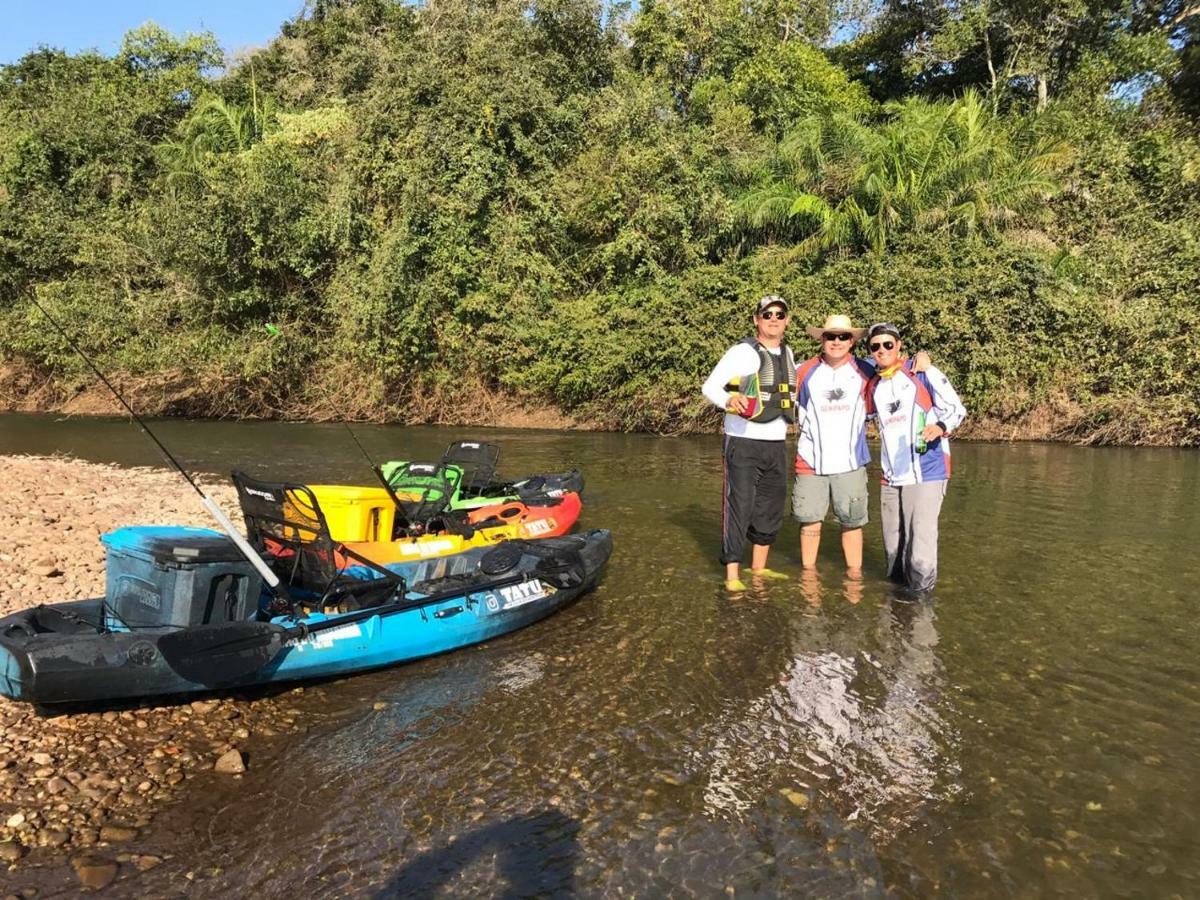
[{"xmin": 880, "ymin": 481, "xmax": 947, "ymax": 590}]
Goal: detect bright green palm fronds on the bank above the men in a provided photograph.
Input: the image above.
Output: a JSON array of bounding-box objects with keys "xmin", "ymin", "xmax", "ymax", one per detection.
[{"xmin": 739, "ymin": 91, "xmax": 1066, "ymax": 254}]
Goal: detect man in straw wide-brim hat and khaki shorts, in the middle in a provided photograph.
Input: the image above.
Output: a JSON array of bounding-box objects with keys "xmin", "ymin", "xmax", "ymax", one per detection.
[{"xmin": 792, "ymin": 314, "xmax": 875, "ymax": 576}]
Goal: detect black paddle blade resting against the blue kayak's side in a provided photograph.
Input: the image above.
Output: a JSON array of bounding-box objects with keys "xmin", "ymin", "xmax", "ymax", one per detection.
[{"xmin": 158, "ymin": 622, "xmax": 288, "ymax": 688}]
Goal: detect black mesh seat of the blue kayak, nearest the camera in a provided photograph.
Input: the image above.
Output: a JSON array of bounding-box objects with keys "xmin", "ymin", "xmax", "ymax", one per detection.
[{"xmin": 232, "ymin": 472, "xmax": 406, "ymax": 607}]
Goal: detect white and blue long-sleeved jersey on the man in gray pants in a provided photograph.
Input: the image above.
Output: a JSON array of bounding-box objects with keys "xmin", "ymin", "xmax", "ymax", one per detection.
[{"xmin": 866, "ymin": 360, "xmax": 967, "ymax": 486}]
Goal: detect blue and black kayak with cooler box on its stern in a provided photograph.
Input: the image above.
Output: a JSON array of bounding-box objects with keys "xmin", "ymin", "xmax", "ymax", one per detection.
[{"xmin": 0, "ymin": 528, "xmax": 612, "ymax": 703}]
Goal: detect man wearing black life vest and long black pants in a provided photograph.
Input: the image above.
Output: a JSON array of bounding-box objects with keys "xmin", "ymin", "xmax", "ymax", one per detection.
[{"xmin": 702, "ymin": 294, "xmax": 796, "ymax": 590}]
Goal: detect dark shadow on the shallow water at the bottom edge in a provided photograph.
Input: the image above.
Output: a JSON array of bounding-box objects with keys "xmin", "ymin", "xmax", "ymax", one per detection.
[{"xmin": 374, "ymin": 810, "xmax": 580, "ymax": 900}]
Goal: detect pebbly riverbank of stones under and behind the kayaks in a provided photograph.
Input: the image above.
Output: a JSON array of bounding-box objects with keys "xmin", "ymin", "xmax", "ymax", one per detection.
[{"xmin": 0, "ymin": 456, "xmax": 302, "ymax": 895}]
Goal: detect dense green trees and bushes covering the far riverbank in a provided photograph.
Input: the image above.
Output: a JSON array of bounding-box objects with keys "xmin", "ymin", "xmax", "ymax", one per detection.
[{"xmin": 0, "ymin": 0, "xmax": 1200, "ymax": 445}]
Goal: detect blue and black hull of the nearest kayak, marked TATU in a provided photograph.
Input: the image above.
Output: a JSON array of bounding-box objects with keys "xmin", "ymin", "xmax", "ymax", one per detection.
[{"xmin": 0, "ymin": 530, "xmax": 612, "ymax": 704}]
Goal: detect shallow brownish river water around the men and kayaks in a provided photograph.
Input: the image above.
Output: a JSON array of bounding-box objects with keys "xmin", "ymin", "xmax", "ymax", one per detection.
[{"xmin": 0, "ymin": 416, "xmax": 1200, "ymax": 898}]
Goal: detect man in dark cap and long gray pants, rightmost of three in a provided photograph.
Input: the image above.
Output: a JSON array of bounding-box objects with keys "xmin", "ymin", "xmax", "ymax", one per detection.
[{"xmin": 866, "ymin": 322, "xmax": 966, "ymax": 592}]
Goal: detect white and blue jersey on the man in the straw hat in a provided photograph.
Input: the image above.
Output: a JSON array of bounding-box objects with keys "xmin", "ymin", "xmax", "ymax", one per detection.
[{"xmin": 796, "ymin": 356, "xmax": 875, "ymax": 475}]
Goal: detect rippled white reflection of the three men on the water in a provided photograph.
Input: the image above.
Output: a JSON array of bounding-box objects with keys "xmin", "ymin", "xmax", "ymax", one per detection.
[{"xmin": 692, "ymin": 600, "xmax": 960, "ymax": 842}]
